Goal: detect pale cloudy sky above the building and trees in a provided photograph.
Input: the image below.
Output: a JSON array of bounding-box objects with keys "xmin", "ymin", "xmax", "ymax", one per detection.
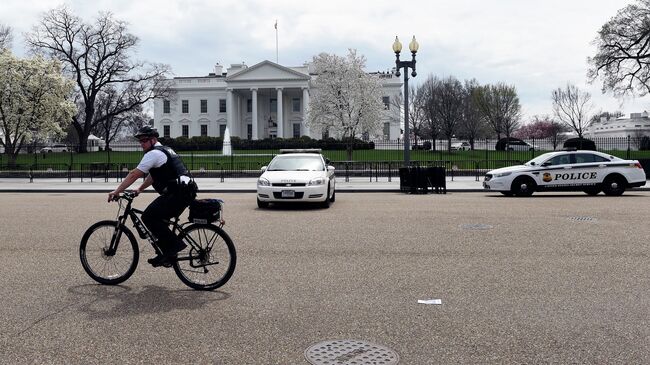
[{"xmin": 0, "ymin": 0, "xmax": 650, "ymax": 120}]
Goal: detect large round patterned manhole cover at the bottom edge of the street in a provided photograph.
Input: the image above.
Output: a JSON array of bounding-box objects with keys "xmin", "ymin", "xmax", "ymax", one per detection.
[{"xmin": 305, "ymin": 340, "xmax": 399, "ymax": 365}]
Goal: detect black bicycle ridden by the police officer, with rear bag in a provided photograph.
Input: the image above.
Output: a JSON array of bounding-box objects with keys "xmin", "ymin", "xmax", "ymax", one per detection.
[{"xmin": 79, "ymin": 192, "xmax": 237, "ymax": 290}]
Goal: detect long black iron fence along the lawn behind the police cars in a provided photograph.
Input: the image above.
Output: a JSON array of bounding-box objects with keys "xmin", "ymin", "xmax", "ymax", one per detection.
[{"xmin": 5, "ymin": 137, "xmax": 650, "ymax": 181}]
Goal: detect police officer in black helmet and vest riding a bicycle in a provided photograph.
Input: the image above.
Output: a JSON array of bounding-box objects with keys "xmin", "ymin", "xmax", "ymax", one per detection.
[{"xmin": 108, "ymin": 126, "xmax": 197, "ymax": 267}]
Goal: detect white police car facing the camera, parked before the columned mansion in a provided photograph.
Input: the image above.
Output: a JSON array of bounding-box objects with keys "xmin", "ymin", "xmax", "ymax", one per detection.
[{"xmin": 257, "ymin": 149, "xmax": 336, "ymax": 208}]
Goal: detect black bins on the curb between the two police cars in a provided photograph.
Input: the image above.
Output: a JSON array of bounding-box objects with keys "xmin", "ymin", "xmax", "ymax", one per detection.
[{"xmin": 399, "ymin": 166, "xmax": 447, "ymax": 194}]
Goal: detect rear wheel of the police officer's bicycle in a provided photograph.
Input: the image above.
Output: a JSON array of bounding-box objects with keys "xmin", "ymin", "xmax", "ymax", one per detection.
[{"xmin": 174, "ymin": 224, "xmax": 237, "ymax": 290}]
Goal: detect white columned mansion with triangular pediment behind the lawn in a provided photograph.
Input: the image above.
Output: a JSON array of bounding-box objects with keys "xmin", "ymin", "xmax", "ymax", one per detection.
[{"xmin": 154, "ymin": 61, "xmax": 402, "ymax": 139}]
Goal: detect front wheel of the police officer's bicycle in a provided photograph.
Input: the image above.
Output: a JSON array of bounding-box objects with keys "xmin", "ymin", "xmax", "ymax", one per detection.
[{"xmin": 79, "ymin": 221, "xmax": 140, "ymax": 285}]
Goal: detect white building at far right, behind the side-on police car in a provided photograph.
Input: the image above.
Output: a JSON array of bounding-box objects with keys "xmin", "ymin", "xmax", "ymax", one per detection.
[{"xmin": 584, "ymin": 111, "xmax": 650, "ymax": 139}]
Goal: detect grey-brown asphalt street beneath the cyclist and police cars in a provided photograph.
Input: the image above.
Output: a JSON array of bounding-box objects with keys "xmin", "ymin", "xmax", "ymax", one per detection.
[{"xmin": 0, "ymin": 191, "xmax": 650, "ymax": 364}]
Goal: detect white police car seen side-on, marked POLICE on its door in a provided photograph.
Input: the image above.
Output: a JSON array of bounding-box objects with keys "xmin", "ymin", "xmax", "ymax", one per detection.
[{"xmin": 483, "ymin": 151, "xmax": 646, "ymax": 196}]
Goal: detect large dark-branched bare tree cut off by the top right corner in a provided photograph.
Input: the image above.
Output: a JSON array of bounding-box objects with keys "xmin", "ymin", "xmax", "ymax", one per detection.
[{"xmin": 587, "ymin": 0, "xmax": 650, "ymax": 96}]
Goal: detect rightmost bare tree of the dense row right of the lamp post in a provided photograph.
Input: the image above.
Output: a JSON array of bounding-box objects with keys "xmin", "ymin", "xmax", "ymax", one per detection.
[{"xmin": 474, "ymin": 83, "xmax": 521, "ymax": 139}]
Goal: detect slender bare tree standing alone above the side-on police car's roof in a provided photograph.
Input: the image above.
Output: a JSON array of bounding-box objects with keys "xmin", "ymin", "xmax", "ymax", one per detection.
[{"xmin": 551, "ymin": 84, "xmax": 593, "ymax": 138}]
